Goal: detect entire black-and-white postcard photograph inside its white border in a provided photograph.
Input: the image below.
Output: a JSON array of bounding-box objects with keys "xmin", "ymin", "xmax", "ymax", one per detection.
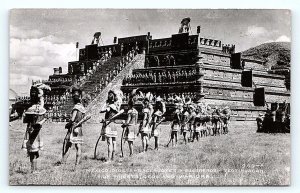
[{"xmin": 6, "ymin": 8, "xmax": 292, "ymax": 186}]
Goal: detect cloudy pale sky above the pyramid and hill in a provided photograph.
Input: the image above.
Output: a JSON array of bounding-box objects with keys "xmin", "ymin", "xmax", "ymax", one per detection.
[{"xmin": 9, "ymin": 9, "xmax": 291, "ymax": 96}]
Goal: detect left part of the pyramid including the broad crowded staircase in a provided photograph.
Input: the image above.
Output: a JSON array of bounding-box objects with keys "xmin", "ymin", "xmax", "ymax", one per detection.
[{"xmin": 27, "ymin": 35, "xmax": 147, "ymax": 121}]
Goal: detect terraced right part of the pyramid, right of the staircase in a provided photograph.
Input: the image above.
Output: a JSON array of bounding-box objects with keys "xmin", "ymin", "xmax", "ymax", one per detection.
[{"xmin": 122, "ymin": 32, "xmax": 290, "ymax": 120}]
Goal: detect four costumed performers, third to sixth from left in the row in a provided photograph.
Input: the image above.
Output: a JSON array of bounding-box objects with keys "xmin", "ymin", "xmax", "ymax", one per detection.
[{"xmin": 94, "ymin": 89, "xmax": 166, "ymax": 162}]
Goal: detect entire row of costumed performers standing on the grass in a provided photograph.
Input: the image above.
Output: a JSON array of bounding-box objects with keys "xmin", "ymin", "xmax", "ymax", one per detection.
[{"xmin": 19, "ymin": 83, "xmax": 230, "ymax": 171}]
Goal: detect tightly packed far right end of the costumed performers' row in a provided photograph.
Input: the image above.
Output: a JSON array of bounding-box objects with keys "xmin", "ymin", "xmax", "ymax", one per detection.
[{"xmin": 167, "ymin": 97, "xmax": 231, "ymax": 146}]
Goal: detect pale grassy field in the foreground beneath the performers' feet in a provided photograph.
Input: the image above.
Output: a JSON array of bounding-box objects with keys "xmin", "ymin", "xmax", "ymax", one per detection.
[{"xmin": 9, "ymin": 121, "xmax": 290, "ymax": 186}]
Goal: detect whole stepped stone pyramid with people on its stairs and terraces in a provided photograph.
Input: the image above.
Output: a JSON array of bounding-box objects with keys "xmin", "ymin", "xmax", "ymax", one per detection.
[{"xmin": 12, "ymin": 21, "xmax": 290, "ymax": 121}]
